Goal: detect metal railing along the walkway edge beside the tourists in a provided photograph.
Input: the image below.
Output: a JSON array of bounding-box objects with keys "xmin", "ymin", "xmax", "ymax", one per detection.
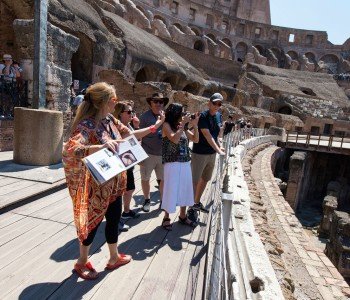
[{"xmin": 203, "ymin": 128, "xmax": 266, "ymax": 300}]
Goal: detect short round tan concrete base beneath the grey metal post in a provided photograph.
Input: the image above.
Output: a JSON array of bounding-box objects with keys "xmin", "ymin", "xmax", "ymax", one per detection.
[{"xmin": 13, "ymin": 107, "xmax": 63, "ymax": 166}]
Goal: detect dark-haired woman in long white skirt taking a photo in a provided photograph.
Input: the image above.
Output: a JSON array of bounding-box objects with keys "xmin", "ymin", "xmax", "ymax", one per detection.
[{"xmin": 162, "ymin": 103, "xmax": 199, "ymax": 230}]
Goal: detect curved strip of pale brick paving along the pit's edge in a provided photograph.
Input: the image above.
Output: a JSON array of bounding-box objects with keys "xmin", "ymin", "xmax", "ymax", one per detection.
[{"xmin": 253, "ymin": 147, "xmax": 350, "ymax": 300}]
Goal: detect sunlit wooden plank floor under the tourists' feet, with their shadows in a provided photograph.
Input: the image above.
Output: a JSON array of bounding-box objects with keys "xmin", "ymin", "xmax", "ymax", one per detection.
[{"xmin": 0, "ymin": 169, "xmax": 208, "ymax": 300}]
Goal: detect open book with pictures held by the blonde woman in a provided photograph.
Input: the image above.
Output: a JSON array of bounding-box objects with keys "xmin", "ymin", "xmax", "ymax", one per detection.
[{"xmin": 83, "ymin": 135, "xmax": 148, "ymax": 184}]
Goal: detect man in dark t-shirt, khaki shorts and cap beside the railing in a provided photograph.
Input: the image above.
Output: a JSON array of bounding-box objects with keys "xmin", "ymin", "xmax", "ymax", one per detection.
[{"xmin": 191, "ymin": 93, "xmax": 225, "ymax": 216}]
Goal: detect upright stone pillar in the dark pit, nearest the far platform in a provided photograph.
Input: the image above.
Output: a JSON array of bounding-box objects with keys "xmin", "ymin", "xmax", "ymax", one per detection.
[{"xmin": 286, "ymin": 151, "xmax": 308, "ymax": 211}]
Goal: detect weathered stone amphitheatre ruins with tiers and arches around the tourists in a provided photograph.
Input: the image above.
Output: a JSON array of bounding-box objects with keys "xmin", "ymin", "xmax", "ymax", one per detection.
[{"xmin": 0, "ymin": 0, "xmax": 350, "ymax": 299}]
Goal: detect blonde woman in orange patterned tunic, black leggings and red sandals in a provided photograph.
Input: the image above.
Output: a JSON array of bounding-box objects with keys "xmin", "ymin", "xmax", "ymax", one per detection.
[{"xmin": 63, "ymin": 82, "xmax": 131, "ymax": 279}]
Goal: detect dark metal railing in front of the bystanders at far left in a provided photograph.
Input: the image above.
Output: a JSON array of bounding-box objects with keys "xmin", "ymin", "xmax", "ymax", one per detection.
[{"xmin": 0, "ymin": 76, "xmax": 29, "ymax": 120}]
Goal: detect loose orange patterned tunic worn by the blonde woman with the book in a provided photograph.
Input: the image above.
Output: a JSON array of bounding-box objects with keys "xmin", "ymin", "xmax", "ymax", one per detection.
[{"xmin": 62, "ymin": 115, "xmax": 130, "ymax": 242}]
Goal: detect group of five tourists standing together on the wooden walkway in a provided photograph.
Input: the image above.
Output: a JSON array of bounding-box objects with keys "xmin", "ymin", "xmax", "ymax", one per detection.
[{"xmin": 63, "ymin": 82, "xmax": 251, "ymax": 279}]
